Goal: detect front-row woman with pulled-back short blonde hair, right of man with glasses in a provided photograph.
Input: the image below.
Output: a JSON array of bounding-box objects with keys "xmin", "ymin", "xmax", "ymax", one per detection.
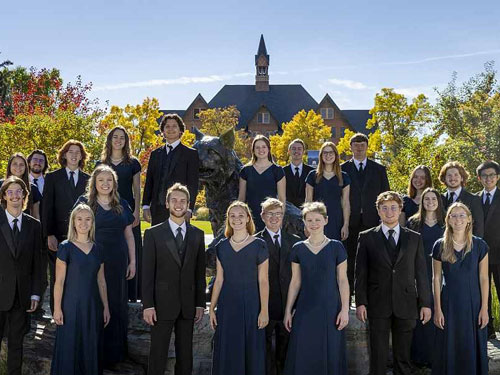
[{"xmin": 284, "ymin": 202, "xmax": 349, "ymax": 375}]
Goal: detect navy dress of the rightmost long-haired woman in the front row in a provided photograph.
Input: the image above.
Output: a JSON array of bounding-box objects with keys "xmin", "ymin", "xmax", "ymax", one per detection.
[{"xmin": 432, "ymin": 236, "xmax": 488, "ymax": 375}]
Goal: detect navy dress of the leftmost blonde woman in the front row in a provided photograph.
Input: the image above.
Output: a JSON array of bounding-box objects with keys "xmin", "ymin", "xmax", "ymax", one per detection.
[{"xmin": 50, "ymin": 240, "xmax": 104, "ymax": 375}]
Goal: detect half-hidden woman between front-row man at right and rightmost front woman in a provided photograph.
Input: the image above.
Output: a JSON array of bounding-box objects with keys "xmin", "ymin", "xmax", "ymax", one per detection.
[{"xmin": 407, "ymin": 188, "xmax": 444, "ymax": 367}]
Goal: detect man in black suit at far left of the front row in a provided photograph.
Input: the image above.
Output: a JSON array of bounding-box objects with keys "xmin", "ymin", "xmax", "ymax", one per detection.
[{"xmin": 0, "ymin": 176, "xmax": 42, "ymax": 375}]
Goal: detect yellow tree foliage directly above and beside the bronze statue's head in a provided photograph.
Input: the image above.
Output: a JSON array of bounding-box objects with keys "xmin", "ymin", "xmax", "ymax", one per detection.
[{"xmin": 200, "ymin": 105, "xmax": 252, "ymax": 163}]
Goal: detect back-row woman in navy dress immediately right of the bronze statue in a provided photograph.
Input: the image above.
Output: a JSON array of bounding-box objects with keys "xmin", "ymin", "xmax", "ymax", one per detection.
[{"xmin": 238, "ymin": 135, "xmax": 286, "ymax": 232}]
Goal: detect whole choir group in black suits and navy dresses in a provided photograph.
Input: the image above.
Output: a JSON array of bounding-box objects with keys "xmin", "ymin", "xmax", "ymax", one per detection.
[{"xmin": 0, "ymin": 114, "xmax": 494, "ymax": 375}]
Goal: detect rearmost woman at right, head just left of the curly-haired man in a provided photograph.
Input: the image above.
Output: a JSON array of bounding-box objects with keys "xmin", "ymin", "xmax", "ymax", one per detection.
[{"xmin": 399, "ymin": 165, "xmax": 432, "ymax": 226}]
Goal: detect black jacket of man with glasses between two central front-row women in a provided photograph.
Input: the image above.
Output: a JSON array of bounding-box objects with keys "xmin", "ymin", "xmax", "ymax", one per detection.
[{"xmin": 255, "ymin": 228, "xmax": 300, "ymax": 320}]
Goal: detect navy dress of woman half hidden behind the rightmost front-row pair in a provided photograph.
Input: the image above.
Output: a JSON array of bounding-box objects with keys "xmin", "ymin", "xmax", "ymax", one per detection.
[{"xmin": 411, "ymin": 224, "xmax": 444, "ymax": 365}]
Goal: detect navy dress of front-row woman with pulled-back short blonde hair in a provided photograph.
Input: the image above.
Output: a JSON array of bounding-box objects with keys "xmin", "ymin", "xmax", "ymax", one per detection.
[{"xmin": 285, "ymin": 240, "xmax": 347, "ymax": 375}]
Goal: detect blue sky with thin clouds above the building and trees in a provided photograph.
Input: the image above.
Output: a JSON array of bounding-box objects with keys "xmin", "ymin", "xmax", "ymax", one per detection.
[{"xmin": 0, "ymin": 0, "xmax": 500, "ymax": 109}]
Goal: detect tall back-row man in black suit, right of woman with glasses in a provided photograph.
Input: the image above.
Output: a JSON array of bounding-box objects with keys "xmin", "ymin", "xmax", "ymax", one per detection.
[{"xmin": 341, "ymin": 133, "xmax": 389, "ymax": 293}]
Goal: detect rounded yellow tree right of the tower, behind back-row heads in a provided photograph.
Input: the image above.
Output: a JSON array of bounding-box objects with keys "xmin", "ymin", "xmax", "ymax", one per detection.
[{"xmin": 270, "ymin": 110, "xmax": 332, "ymax": 165}]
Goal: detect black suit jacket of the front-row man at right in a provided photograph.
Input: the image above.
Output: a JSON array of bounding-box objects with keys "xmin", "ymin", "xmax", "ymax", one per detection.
[{"xmin": 354, "ymin": 225, "xmax": 431, "ymax": 319}]
